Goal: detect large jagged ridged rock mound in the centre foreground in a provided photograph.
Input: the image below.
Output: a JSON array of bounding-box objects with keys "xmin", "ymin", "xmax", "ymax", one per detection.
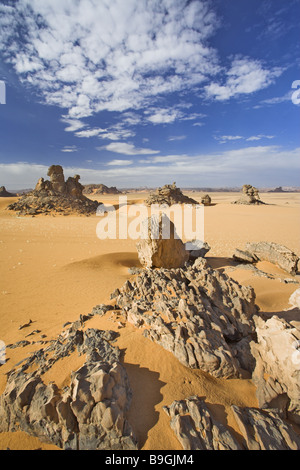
[{"xmin": 112, "ymin": 258, "xmax": 257, "ymax": 378}]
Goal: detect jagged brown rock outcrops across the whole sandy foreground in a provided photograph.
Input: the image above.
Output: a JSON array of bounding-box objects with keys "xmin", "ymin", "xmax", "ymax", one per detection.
[{"xmin": 0, "ymin": 250, "xmax": 300, "ymax": 450}]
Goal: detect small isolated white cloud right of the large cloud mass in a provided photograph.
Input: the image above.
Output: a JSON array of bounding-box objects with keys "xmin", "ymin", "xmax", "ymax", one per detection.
[{"xmin": 205, "ymin": 58, "xmax": 284, "ymax": 101}]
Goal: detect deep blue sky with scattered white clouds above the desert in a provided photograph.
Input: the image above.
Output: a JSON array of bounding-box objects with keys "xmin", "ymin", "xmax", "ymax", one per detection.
[{"xmin": 0, "ymin": 0, "xmax": 300, "ymax": 188}]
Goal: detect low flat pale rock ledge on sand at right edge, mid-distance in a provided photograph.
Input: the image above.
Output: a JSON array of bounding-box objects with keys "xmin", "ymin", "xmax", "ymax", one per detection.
[{"xmin": 233, "ymin": 242, "xmax": 300, "ymax": 276}]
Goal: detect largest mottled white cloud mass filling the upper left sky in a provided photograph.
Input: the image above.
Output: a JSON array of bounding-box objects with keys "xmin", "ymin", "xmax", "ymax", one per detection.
[{"xmin": 0, "ymin": 0, "xmax": 218, "ymax": 120}]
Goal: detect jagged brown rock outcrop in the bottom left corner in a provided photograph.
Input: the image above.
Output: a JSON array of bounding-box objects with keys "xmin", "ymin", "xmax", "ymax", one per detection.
[{"xmin": 0, "ymin": 318, "xmax": 137, "ymax": 450}]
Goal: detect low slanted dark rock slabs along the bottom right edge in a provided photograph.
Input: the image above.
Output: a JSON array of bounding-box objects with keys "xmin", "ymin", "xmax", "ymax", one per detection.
[{"xmin": 164, "ymin": 396, "xmax": 300, "ymax": 450}]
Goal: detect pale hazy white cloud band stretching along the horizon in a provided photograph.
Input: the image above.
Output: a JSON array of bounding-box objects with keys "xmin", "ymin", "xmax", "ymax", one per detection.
[{"xmin": 0, "ymin": 146, "xmax": 300, "ymax": 189}]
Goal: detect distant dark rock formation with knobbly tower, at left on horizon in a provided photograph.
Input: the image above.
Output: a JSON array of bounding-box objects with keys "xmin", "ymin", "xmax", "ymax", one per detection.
[{"xmin": 7, "ymin": 165, "xmax": 99, "ymax": 215}]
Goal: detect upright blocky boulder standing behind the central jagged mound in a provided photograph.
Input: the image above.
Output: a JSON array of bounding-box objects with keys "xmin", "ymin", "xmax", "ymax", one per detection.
[{"xmin": 136, "ymin": 214, "xmax": 189, "ymax": 268}]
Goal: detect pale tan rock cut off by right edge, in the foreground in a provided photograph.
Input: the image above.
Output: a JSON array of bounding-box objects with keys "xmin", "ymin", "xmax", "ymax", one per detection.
[{"xmin": 250, "ymin": 309, "xmax": 300, "ymax": 424}]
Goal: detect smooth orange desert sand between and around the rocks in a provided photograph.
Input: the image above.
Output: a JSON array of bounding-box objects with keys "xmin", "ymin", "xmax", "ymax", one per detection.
[{"xmin": 0, "ymin": 192, "xmax": 300, "ymax": 450}]
